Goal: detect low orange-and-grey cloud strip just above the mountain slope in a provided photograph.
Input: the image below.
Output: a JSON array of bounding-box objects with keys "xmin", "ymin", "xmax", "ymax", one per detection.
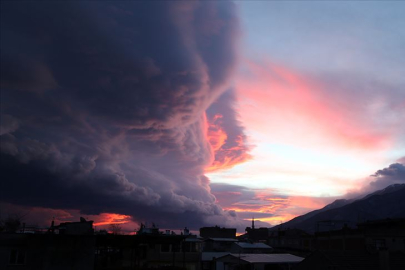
[{"xmin": 211, "ymin": 158, "xmax": 405, "ymax": 227}]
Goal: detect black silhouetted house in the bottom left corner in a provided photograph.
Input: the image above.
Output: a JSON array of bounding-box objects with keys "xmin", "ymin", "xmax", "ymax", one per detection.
[{"xmin": 0, "ymin": 233, "xmax": 95, "ymax": 270}]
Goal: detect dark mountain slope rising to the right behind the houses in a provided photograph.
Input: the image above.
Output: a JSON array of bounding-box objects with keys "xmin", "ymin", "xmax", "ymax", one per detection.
[{"xmin": 270, "ymin": 184, "xmax": 405, "ymax": 233}]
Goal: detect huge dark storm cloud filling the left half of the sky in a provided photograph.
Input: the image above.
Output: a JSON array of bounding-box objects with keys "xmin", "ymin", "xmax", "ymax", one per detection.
[{"xmin": 1, "ymin": 1, "xmax": 241, "ymax": 227}]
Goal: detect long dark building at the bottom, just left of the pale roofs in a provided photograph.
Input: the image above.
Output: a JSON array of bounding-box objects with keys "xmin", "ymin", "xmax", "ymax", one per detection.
[{"xmin": 95, "ymin": 228, "xmax": 203, "ymax": 270}]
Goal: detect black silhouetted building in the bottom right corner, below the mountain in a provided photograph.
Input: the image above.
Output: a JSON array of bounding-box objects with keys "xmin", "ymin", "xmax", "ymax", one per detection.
[{"xmin": 297, "ymin": 219, "xmax": 405, "ymax": 270}]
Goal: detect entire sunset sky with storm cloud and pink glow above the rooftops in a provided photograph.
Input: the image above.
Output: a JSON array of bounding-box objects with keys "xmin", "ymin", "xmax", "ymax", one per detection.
[{"xmin": 0, "ymin": 1, "xmax": 405, "ymax": 232}]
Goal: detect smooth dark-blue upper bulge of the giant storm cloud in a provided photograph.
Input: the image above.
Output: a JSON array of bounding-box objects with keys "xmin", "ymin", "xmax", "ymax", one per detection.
[{"xmin": 1, "ymin": 2, "xmax": 236, "ymax": 128}]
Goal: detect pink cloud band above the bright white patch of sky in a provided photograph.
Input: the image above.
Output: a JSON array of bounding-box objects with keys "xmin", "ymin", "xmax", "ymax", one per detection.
[{"xmin": 236, "ymin": 61, "xmax": 397, "ymax": 149}]
